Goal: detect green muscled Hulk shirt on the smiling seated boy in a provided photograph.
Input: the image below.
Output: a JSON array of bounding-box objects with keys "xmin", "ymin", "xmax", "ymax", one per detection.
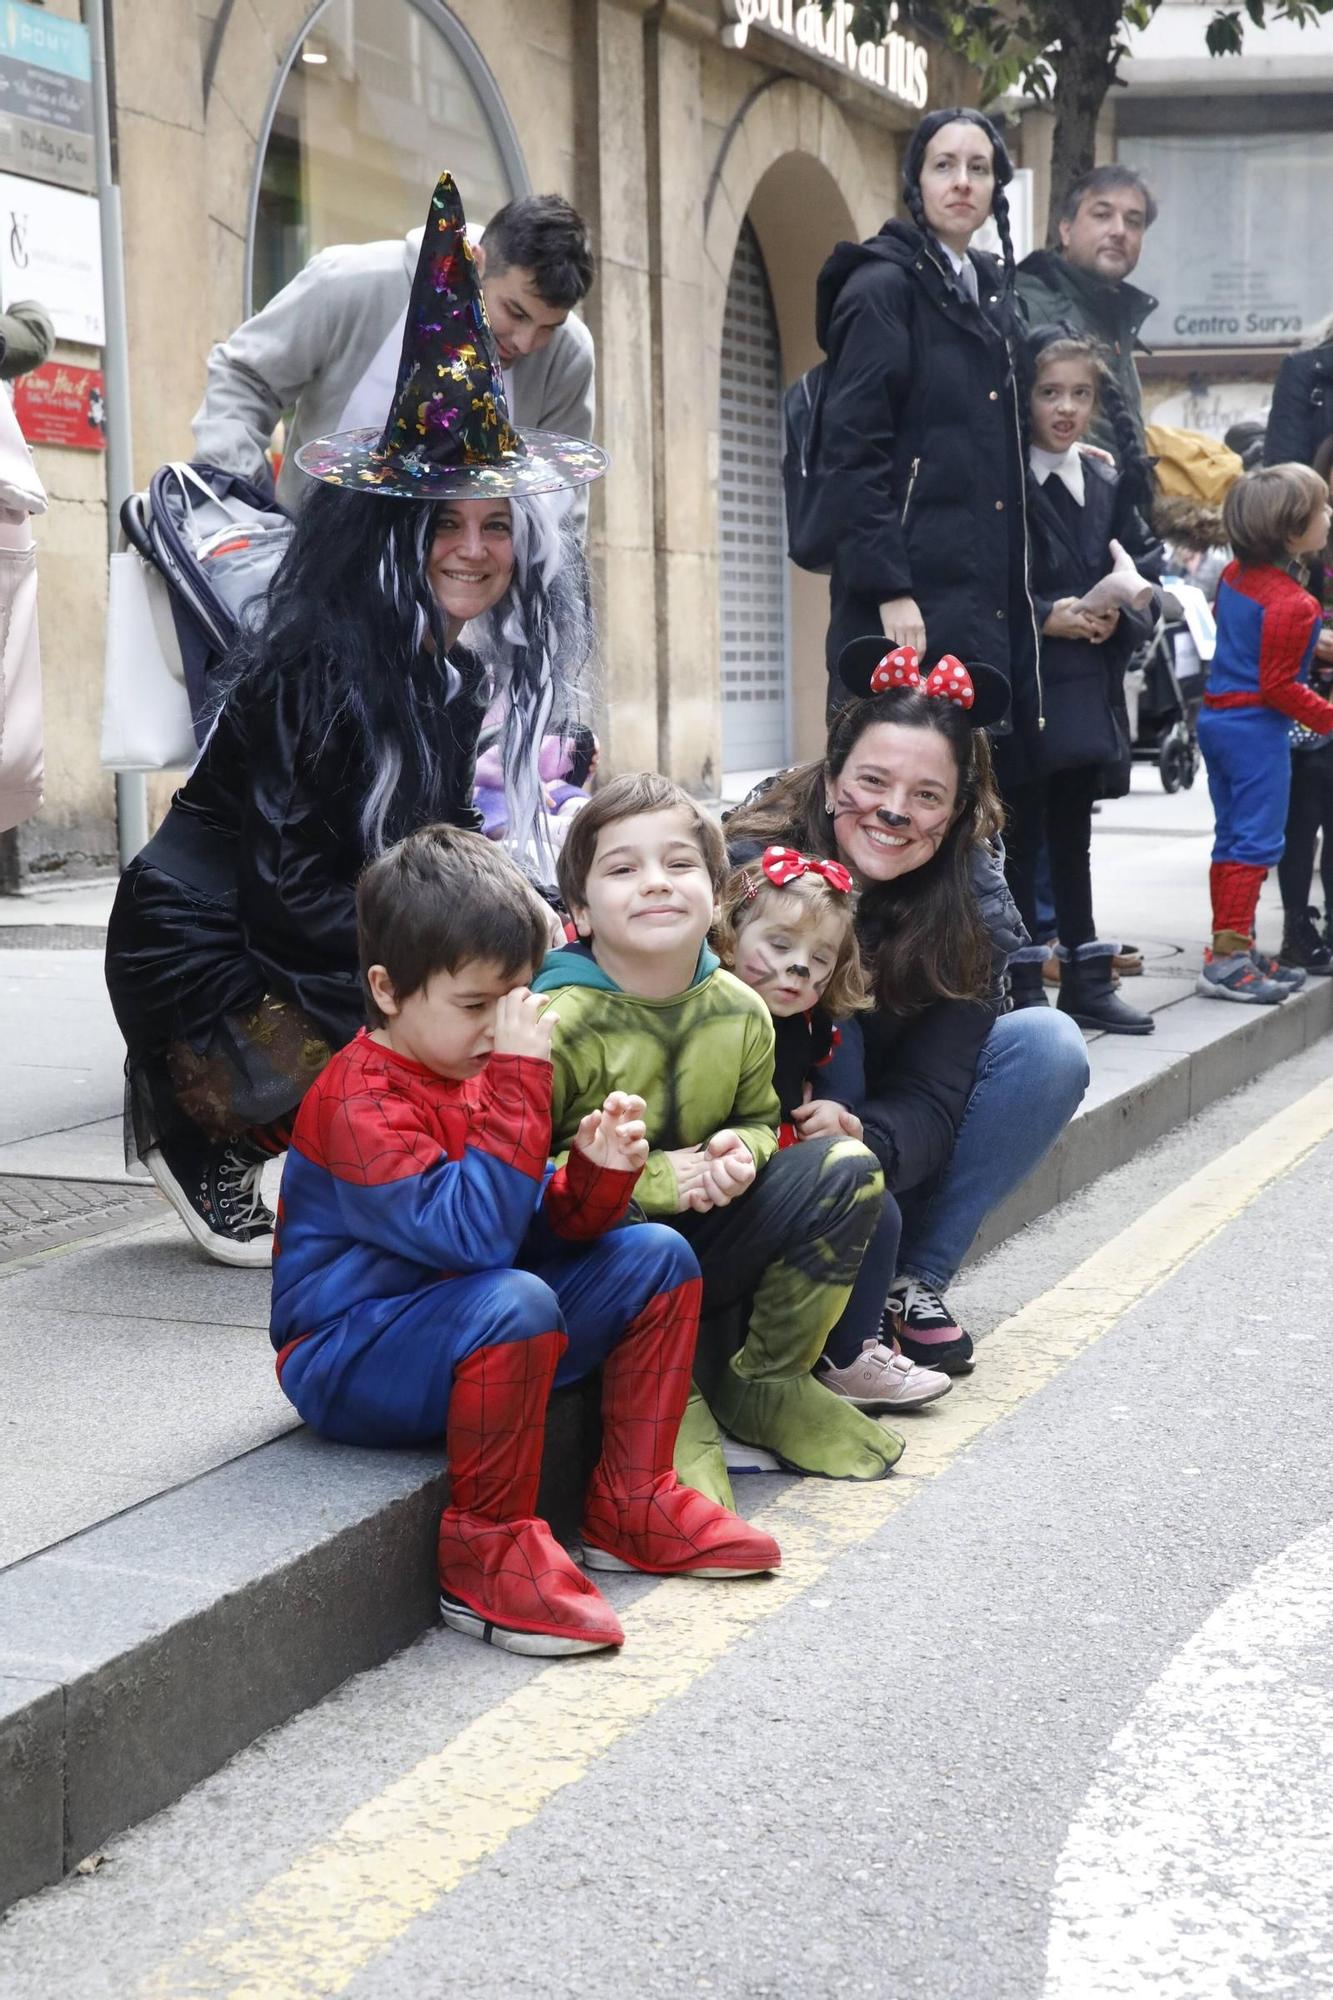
[{"xmin": 532, "ymin": 944, "xmax": 779, "ymax": 1216}]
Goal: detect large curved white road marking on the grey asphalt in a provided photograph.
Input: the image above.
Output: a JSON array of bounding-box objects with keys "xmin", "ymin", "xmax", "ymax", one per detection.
[{"xmin": 1043, "ymin": 1522, "xmax": 1333, "ymax": 2000}]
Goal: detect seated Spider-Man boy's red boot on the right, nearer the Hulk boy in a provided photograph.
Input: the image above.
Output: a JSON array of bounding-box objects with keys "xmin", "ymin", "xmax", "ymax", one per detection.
[{"xmin": 582, "ymin": 1278, "xmax": 783, "ymax": 1576}]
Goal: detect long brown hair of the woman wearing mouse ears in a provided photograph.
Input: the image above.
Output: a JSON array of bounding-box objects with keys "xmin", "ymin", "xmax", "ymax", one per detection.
[{"xmin": 728, "ymin": 688, "xmax": 1003, "ymax": 1016}]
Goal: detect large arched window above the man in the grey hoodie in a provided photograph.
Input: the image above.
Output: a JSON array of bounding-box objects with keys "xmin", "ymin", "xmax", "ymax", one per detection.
[{"xmin": 246, "ymin": 0, "xmax": 528, "ymax": 310}]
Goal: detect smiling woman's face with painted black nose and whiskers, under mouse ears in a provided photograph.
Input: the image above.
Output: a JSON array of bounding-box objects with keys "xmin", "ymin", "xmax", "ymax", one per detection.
[{"xmin": 825, "ymin": 722, "xmax": 959, "ymax": 882}]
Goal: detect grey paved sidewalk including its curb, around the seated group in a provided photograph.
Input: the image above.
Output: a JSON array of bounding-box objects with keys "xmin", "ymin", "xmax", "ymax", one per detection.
[{"xmin": 0, "ymin": 770, "xmax": 1333, "ymax": 1906}]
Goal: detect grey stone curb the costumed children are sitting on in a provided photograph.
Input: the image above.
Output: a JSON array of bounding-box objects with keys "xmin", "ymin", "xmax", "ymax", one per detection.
[{"xmin": 0, "ymin": 980, "xmax": 1333, "ymax": 1908}]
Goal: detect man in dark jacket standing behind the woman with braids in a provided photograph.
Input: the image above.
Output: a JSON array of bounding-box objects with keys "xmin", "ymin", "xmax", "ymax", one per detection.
[{"xmin": 1017, "ymin": 166, "xmax": 1157, "ymax": 458}]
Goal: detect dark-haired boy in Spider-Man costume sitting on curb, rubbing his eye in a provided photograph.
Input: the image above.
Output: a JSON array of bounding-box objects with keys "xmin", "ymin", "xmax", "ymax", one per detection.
[{"xmin": 270, "ymin": 826, "xmax": 781, "ymax": 1654}]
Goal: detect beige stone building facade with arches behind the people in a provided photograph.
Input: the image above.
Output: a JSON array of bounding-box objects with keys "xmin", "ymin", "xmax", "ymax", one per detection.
[{"xmin": 8, "ymin": 0, "xmax": 975, "ymax": 878}]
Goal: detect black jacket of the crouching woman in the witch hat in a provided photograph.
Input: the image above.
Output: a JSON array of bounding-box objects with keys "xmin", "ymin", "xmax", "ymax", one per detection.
[{"xmin": 106, "ymin": 648, "xmax": 484, "ymax": 1060}]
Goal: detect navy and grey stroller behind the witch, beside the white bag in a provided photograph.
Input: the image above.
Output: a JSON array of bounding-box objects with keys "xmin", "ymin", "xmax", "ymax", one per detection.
[{"xmin": 120, "ymin": 460, "xmax": 292, "ymax": 744}]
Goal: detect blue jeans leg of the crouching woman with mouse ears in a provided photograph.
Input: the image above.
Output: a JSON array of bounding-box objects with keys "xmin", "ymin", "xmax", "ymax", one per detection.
[{"xmin": 899, "ymin": 1008, "xmax": 1089, "ymax": 1292}]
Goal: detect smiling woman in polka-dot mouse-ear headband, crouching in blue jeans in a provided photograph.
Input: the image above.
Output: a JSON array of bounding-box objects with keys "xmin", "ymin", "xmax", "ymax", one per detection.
[{"xmin": 727, "ymin": 636, "xmax": 1089, "ymax": 1400}]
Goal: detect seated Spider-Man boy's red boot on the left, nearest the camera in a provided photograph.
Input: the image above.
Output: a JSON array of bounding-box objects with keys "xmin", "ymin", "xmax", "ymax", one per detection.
[{"xmin": 440, "ymin": 1332, "xmax": 624, "ymax": 1656}]
